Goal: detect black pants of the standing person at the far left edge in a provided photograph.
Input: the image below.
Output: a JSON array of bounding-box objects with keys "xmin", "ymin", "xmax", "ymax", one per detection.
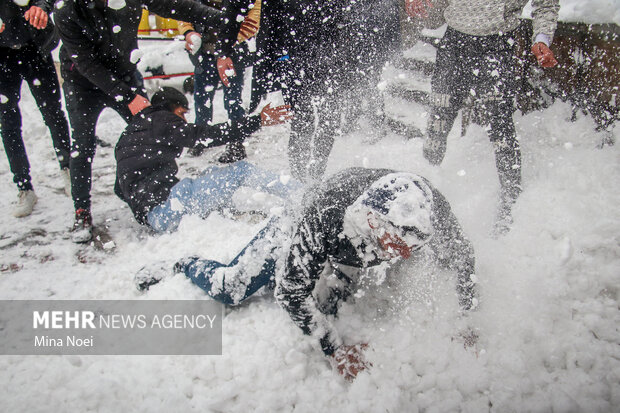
[{"xmin": 0, "ymin": 43, "xmax": 70, "ymax": 190}]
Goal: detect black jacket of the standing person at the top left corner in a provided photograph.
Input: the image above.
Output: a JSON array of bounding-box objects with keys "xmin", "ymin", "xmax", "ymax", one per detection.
[{"xmin": 0, "ymin": 0, "xmax": 58, "ymax": 55}]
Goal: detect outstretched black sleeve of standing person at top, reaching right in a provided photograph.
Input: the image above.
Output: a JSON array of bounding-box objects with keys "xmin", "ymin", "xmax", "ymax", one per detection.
[{"xmin": 142, "ymin": 0, "xmax": 221, "ymax": 30}]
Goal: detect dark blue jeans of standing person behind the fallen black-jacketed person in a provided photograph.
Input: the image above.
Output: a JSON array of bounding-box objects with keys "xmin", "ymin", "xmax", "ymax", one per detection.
[{"xmin": 194, "ymin": 53, "xmax": 245, "ymax": 125}]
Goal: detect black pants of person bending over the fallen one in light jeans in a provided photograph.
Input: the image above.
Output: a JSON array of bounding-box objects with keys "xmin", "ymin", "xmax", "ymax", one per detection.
[{"xmin": 63, "ymin": 77, "xmax": 141, "ymax": 210}]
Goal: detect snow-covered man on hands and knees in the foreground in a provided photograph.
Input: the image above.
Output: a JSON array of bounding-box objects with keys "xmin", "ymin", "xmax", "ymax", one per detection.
[{"xmin": 175, "ymin": 168, "xmax": 477, "ymax": 379}]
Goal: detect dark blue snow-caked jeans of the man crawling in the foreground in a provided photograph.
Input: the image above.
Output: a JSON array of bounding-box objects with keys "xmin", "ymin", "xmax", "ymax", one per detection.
[{"xmin": 177, "ymin": 217, "xmax": 282, "ymax": 305}]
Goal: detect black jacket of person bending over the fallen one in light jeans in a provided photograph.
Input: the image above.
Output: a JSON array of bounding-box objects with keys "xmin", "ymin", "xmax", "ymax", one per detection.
[{"xmin": 54, "ymin": 0, "xmax": 221, "ymax": 104}]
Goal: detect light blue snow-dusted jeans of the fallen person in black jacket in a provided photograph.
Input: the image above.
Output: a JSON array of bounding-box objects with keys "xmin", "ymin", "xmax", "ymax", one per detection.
[{"xmin": 147, "ymin": 161, "xmax": 299, "ymax": 232}]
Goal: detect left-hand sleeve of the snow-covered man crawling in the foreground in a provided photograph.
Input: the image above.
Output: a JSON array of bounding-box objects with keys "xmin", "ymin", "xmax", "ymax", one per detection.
[{"xmin": 276, "ymin": 209, "xmax": 342, "ymax": 355}]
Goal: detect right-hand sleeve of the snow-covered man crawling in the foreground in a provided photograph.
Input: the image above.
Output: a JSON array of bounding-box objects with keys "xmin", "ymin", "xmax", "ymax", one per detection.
[{"xmin": 430, "ymin": 190, "xmax": 477, "ymax": 311}]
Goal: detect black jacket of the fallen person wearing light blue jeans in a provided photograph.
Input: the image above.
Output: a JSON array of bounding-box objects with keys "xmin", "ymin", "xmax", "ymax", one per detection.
[{"xmin": 114, "ymin": 106, "xmax": 260, "ymax": 224}]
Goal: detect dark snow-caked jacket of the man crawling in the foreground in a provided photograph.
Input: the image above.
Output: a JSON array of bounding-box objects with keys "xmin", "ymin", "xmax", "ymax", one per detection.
[{"xmin": 276, "ymin": 168, "xmax": 475, "ymax": 355}]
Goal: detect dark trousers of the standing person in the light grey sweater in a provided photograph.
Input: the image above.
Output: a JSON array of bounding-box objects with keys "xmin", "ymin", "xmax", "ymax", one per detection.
[{"xmin": 428, "ymin": 28, "xmax": 521, "ymax": 200}]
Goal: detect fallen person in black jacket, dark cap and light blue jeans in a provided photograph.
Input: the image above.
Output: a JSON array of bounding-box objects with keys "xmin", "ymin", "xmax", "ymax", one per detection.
[{"xmin": 114, "ymin": 87, "xmax": 291, "ymax": 232}]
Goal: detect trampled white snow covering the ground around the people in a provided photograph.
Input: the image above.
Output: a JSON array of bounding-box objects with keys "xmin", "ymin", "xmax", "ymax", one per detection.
[{"xmin": 0, "ymin": 1, "xmax": 620, "ymax": 412}]
